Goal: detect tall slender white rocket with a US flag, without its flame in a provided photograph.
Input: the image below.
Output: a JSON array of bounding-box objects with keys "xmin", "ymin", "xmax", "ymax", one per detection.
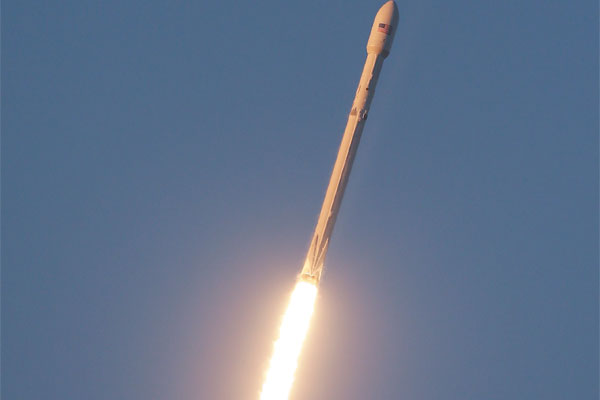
[{"xmin": 300, "ymin": 0, "xmax": 398, "ymax": 284}]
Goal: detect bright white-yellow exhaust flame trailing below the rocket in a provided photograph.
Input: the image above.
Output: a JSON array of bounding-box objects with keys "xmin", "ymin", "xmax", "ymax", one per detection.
[{"xmin": 260, "ymin": 281, "xmax": 317, "ymax": 400}]
